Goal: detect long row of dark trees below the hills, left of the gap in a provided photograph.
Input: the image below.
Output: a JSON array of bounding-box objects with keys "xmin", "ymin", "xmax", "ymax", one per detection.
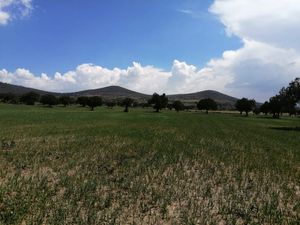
[{"xmin": 0, "ymin": 92, "xmax": 218, "ymax": 113}]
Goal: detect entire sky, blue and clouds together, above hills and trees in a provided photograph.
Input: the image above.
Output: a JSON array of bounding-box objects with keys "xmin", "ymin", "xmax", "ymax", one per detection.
[{"xmin": 0, "ymin": 0, "xmax": 300, "ymax": 101}]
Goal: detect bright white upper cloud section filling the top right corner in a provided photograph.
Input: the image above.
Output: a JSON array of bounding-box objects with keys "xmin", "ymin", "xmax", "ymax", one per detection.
[{"xmin": 210, "ymin": 0, "xmax": 300, "ymax": 50}]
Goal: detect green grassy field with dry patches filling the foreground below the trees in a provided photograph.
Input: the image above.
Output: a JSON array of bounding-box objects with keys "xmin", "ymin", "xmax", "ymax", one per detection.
[{"xmin": 0, "ymin": 105, "xmax": 300, "ymax": 225}]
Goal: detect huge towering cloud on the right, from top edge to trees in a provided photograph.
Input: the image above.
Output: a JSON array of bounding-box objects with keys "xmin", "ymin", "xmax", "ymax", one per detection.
[{"xmin": 204, "ymin": 0, "xmax": 300, "ymax": 100}]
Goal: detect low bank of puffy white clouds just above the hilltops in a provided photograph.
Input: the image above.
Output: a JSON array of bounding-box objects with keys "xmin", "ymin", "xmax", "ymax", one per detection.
[{"xmin": 0, "ymin": 60, "xmax": 231, "ymax": 94}]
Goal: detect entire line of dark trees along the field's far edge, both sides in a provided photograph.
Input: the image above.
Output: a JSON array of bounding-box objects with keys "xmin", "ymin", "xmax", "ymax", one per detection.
[{"xmin": 0, "ymin": 78, "xmax": 300, "ymax": 118}]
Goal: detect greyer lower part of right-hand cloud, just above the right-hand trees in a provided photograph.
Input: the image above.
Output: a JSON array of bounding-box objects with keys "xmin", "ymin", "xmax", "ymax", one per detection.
[{"xmin": 208, "ymin": 41, "xmax": 300, "ymax": 101}]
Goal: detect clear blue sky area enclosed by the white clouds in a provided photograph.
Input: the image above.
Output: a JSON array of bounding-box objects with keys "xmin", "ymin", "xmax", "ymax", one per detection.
[{"xmin": 0, "ymin": 0, "xmax": 241, "ymax": 74}]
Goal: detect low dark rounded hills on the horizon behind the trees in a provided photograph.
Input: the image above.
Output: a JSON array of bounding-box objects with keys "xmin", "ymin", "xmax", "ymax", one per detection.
[{"xmin": 0, "ymin": 82, "xmax": 237, "ymax": 109}]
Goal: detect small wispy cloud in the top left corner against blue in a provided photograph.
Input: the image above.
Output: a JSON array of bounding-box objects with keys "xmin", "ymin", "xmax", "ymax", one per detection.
[{"xmin": 0, "ymin": 0, "xmax": 33, "ymax": 25}]
